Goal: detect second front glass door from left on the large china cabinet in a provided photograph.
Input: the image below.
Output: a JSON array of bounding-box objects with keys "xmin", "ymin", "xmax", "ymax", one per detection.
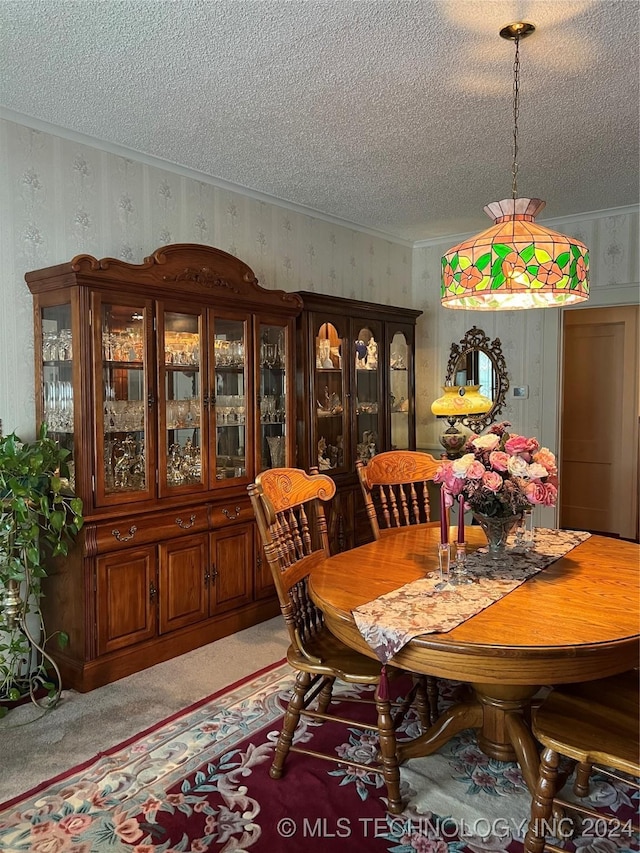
[{"xmin": 158, "ymin": 307, "xmax": 207, "ymax": 494}]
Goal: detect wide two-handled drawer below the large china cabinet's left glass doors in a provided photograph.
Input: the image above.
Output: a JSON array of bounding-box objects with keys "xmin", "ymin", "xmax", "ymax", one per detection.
[{"xmin": 86, "ymin": 504, "xmax": 209, "ymax": 554}]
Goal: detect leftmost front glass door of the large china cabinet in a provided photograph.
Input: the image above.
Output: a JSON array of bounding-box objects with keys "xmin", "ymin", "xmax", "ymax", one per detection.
[{"xmin": 93, "ymin": 294, "xmax": 155, "ymax": 504}]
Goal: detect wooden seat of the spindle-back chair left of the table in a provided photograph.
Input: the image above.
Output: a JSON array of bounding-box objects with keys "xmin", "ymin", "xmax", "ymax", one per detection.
[{"xmin": 287, "ymin": 626, "xmax": 397, "ymax": 684}]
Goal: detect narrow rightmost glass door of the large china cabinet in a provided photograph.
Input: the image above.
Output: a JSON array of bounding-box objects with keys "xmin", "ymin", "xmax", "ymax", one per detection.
[{"xmin": 256, "ymin": 323, "xmax": 288, "ymax": 471}]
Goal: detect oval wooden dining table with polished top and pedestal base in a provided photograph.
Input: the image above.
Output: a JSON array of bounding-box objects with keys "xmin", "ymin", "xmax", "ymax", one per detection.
[{"xmin": 309, "ymin": 526, "xmax": 640, "ymax": 791}]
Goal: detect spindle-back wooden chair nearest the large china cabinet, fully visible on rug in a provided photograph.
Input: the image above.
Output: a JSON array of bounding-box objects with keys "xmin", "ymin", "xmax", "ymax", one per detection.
[{"xmin": 248, "ymin": 468, "xmax": 428, "ymax": 814}]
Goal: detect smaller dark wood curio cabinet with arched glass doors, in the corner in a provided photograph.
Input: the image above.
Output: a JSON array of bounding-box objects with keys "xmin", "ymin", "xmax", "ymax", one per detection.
[{"xmin": 296, "ymin": 292, "xmax": 422, "ymax": 551}]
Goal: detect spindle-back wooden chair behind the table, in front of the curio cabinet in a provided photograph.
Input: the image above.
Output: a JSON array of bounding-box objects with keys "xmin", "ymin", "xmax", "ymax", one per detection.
[{"xmin": 356, "ymin": 450, "xmax": 441, "ymax": 723}]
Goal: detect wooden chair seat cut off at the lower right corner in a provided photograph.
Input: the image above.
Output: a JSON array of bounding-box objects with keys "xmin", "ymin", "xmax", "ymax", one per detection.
[{"xmin": 533, "ymin": 671, "xmax": 640, "ymax": 774}]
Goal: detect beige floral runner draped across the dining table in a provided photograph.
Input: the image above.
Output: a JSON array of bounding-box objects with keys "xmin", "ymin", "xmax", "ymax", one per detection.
[{"xmin": 353, "ymin": 528, "xmax": 591, "ymax": 663}]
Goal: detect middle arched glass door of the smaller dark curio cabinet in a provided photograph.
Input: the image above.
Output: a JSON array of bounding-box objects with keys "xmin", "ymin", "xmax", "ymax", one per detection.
[{"xmin": 352, "ymin": 322, "xmax": 384, "ymax": 462}]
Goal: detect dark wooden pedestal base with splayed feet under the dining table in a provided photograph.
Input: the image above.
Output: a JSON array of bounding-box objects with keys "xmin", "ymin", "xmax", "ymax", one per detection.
[{"xmin": 398, "ymin": 684, "xmax": 539, "ymax": 793}]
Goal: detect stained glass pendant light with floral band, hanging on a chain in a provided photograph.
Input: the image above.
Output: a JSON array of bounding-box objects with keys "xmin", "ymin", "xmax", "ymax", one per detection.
[{"xmin": 442, "ymin": 21, "xmax": 589, "ymax": 311}]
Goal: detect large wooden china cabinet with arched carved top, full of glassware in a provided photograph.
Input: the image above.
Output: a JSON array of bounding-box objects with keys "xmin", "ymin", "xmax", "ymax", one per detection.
[{"xmin": 25, "ymin": 244, "xmax": 302, "ymax": 691}]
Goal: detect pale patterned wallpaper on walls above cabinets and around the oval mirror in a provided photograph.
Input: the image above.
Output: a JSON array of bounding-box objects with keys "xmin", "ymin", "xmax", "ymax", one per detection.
[{"xmin": 0, "ymin": 121, "xmax": 640, "ymax": 449}]
